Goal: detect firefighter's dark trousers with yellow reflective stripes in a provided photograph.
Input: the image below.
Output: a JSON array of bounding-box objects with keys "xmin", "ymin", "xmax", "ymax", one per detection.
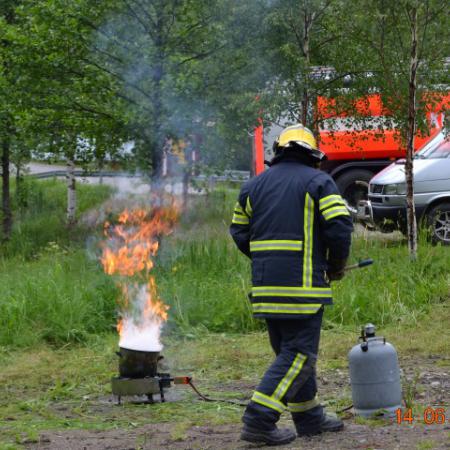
[{"xmin": 242, "ymin": 307, "xmax": 324, "ymax": 430}]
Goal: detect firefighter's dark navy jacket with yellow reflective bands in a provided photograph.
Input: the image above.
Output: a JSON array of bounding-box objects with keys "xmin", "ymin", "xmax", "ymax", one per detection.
[{"xmin": 230, "ymin": 159, "xmax": 353, "ymax": 318}]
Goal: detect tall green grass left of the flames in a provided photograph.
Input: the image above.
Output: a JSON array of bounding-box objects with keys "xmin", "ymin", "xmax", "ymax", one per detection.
[{"xmin": 0, "ymin": 251, "xmax": 117, "ymax": 347}]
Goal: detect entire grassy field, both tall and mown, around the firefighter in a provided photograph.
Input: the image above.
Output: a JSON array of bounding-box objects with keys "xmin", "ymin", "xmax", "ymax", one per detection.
[{"xmin": 0, "ymin": 181, "xmax": 450, "ymax": 450}]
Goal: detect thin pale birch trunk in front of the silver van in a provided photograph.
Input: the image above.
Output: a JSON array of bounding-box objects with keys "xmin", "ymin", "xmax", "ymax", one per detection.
[{"xmin": 405, "ymin": 8, "xmax": 418, "ymax": 260}]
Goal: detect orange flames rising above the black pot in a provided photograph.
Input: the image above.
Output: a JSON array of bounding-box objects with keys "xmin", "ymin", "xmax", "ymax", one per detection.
[{"xmin": 101, "ymin": 201, "xmax": 179, "ymax": 337}]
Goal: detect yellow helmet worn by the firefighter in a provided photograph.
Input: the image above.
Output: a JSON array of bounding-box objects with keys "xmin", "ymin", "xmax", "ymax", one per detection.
[{"xmin": 273, "ymin": 123, "xmax": 326, "ymax": 161}]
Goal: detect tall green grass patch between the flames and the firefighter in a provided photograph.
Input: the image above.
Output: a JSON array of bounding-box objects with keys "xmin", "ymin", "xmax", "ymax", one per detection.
[{"xmin": 158, "ymin": 236, "xmax": 257, "ymax": 332}]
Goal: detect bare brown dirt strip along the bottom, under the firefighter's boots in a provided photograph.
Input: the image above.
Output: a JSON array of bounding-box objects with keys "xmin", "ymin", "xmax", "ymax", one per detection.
[{"xmin": 28, "ymin": 421, "xmax": 450, "ymax": 450}]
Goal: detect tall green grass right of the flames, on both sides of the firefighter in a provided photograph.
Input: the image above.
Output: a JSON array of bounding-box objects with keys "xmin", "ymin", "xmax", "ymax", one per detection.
[{"xmin": 157, "ymin": 192, "xmax": 450, "ymax": 331}]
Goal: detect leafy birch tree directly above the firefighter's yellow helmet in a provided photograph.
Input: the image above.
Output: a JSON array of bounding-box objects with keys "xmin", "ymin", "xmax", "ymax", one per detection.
[{"xmin": 265, "ymin": 0, "xmax": 351, "ymax": 133}]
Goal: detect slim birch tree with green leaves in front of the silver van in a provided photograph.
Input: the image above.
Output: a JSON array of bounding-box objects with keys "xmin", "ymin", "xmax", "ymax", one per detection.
[{"xmin": 331, "ymin": 0, "xmax": 450, "ymax": 259}]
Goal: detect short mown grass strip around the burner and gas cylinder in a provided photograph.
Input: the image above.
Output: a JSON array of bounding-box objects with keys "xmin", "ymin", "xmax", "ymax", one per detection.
[{"xmin": 0, "ymin": 305, "xmax": 450, "ymax": 448}]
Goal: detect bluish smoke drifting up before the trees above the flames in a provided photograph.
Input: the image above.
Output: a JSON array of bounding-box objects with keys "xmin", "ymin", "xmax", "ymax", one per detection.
[{"xmin": 92, "ymin": 0, "xmax": 272, "ymax": 172}]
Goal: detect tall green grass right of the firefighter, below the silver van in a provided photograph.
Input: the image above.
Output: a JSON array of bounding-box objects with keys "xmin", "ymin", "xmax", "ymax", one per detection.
[{"xmin": 326, "ymin": 237, "xmax": 450, "ymax": 325}]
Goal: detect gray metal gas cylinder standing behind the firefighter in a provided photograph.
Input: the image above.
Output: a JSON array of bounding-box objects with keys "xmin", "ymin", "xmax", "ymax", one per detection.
[{"xmin": 348, "ymin": 324, "xmax": 402, "ymax": 417}]
